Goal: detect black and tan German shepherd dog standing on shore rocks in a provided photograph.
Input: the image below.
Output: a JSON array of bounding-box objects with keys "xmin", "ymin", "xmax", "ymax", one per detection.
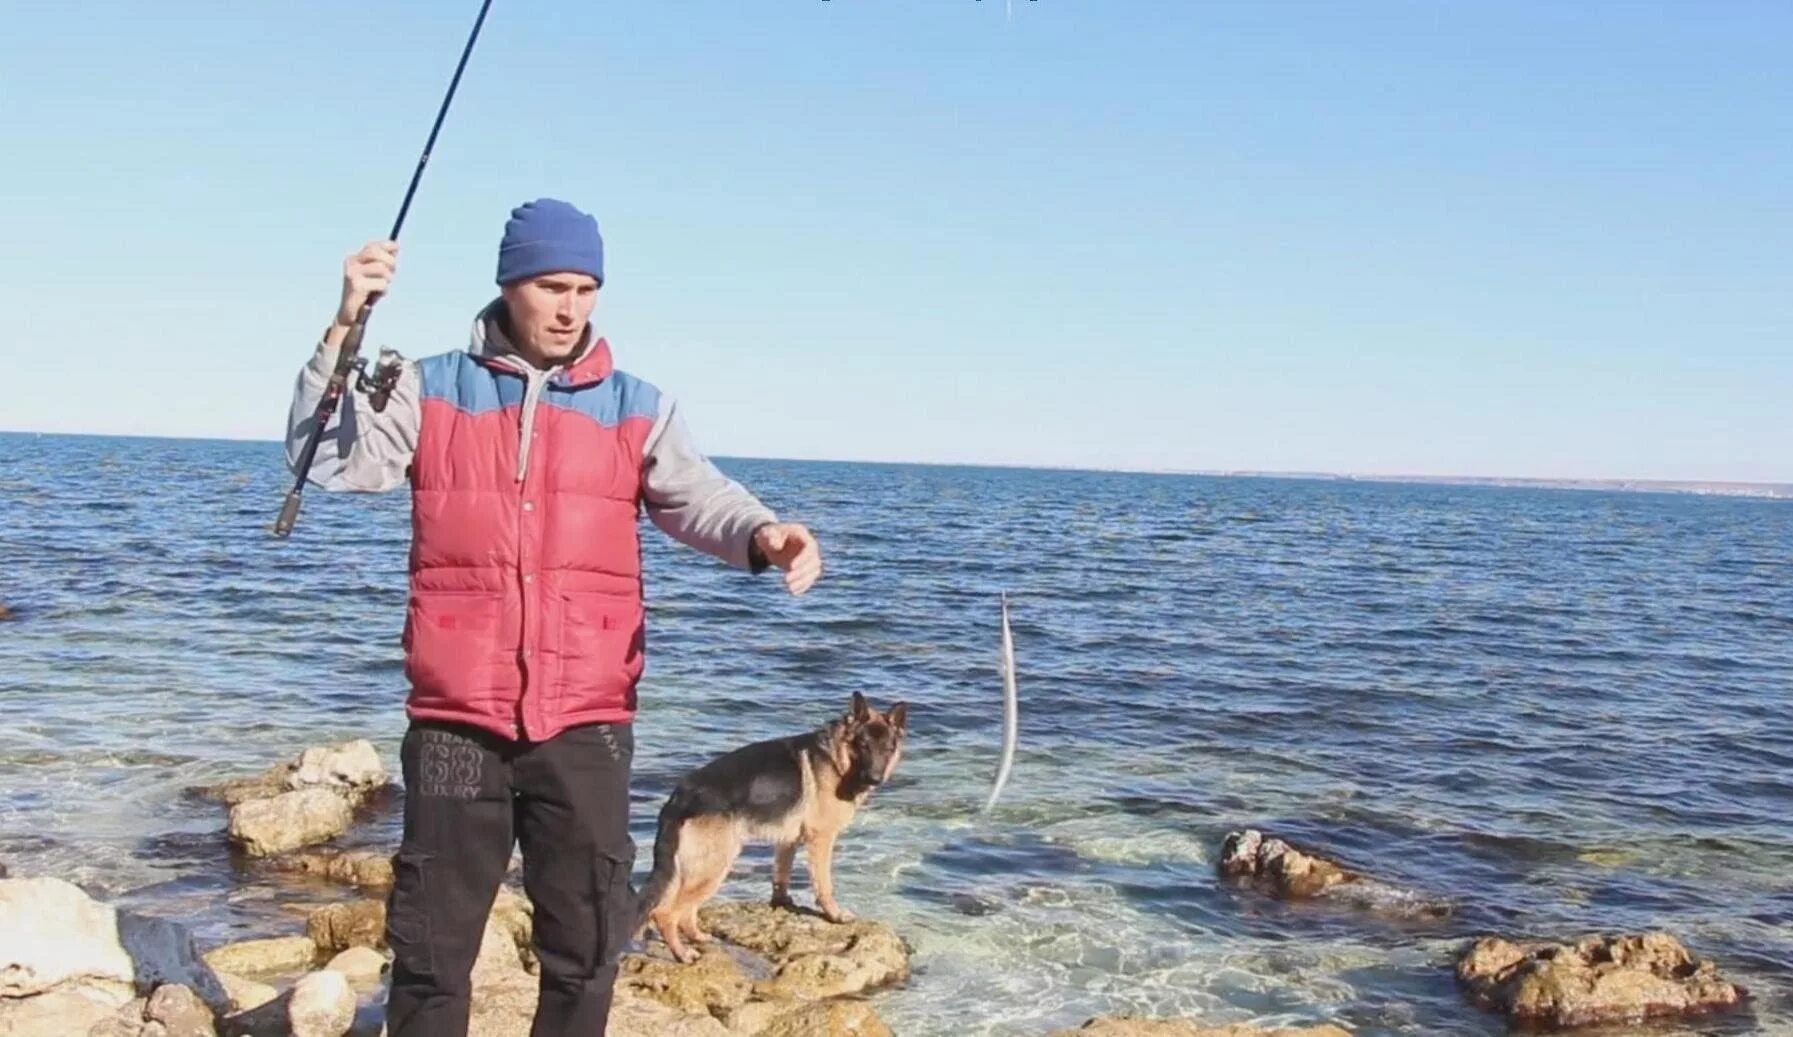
[{"xmin": 635, "ymin": 691, "xmax": 909, "ymax": 963}]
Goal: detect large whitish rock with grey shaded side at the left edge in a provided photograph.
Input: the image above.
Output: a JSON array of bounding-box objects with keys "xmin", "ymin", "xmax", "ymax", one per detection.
[{"xmin": 0, "ymin": 877, "xmax": 228, "ymax": 1007}]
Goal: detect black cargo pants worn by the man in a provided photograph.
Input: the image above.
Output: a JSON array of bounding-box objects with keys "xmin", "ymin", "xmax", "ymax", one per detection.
[{"xmin": 385, "ymin": 721, "xmax": 635, "ymax": 1037}]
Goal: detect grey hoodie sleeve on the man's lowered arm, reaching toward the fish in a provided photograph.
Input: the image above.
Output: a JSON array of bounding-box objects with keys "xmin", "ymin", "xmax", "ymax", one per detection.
[{"xmin": 642, "ymin": 397, "xmax": 778, "ymax": 572}]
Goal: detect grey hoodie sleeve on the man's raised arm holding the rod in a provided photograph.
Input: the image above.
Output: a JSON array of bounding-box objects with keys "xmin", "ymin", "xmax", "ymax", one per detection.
[{"xmin": 287, "ymin": 333, "xmax": 423, "ymax": 493}]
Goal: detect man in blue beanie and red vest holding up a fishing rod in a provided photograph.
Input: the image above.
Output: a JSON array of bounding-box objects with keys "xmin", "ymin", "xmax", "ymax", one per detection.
[{"xmin": 287, "ymin": 199, "xmax": 821, "ymax": 1037}]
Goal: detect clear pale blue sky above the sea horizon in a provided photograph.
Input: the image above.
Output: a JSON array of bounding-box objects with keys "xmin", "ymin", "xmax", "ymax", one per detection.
[{"xmin": 0, "ymin": 0, "xmax": 1793, "ymax": 481}]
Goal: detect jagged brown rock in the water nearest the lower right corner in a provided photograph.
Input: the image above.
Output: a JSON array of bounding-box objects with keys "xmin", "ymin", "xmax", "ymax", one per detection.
[{"xmin": 1458, "ymin": 933, "xmax": 1748, "ymax": 1026}]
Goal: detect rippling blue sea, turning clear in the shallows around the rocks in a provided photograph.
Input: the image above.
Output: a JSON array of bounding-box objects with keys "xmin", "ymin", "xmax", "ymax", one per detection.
[{"xmin": 0, "ymin": 434, "xmax": 1793, "ymax": 1035}]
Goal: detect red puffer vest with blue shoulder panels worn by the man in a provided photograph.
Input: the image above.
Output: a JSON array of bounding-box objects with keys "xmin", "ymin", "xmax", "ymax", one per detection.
[{"xmin": 405, "ymin": 339, "xmax": 660, "ymax": 741}]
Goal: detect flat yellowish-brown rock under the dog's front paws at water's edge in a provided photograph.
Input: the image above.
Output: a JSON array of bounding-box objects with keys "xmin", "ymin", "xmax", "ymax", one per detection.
[{"xmin": 699, "ymin": 902, "xmax": 909, "ymax": 999}]
